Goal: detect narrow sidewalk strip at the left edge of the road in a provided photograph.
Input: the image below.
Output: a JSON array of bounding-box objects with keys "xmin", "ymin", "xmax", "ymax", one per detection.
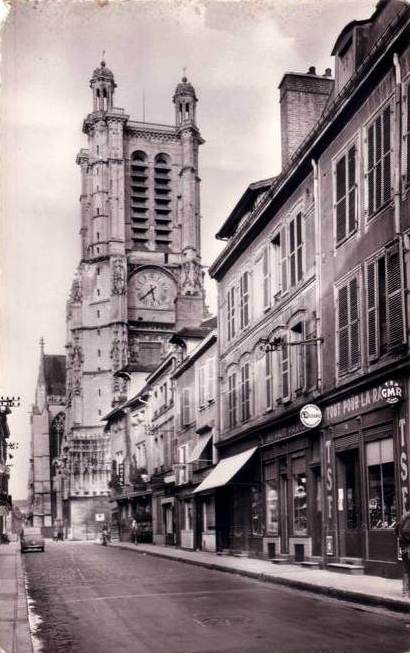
[{"xmin": 0, "ymin": 542, "xmax": 33, "ymax": 653}]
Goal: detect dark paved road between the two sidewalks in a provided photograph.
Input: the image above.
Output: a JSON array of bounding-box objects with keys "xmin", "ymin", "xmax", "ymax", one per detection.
[{"xmin": 24, "ymin": 542, "xmax": 410, "ymax": 653}]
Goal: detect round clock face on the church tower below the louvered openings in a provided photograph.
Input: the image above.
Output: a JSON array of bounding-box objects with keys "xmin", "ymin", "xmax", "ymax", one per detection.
[{"xmin": 134, "ymin": 270, "xmax": 175, "ymax": 309}]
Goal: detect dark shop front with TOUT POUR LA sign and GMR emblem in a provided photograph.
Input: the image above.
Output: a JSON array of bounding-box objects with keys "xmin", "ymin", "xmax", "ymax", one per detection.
[{"xmin": 322, "ymin": 379, "xmax": 409, "ymax": 577}]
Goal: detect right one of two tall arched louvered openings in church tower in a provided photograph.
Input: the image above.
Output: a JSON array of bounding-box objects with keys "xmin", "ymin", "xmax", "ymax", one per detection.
[{"xmin": 154, "ymin": 154, "xmax": 172, "ymax": 249}]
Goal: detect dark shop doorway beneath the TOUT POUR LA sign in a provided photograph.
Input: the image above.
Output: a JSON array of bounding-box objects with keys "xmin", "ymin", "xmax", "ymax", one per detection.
[{"xmin": 336, "ymin": 449, "xmax": 364, "ymax": 558}]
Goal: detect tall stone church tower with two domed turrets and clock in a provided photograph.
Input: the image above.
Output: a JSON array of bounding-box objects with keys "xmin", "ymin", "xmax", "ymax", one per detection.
[{"xmin": 64, "ymin": 61, "xmax": 204, "ymax": 538}]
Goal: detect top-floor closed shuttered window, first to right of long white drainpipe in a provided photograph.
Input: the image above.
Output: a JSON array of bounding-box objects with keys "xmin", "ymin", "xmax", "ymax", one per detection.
[{"xmin": 335, "ymin": 145, "xmax": 357, "ymax": 244}]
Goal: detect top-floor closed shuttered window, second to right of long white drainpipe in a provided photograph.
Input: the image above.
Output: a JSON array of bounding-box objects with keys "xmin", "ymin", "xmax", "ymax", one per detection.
[{"xmin": 367, "ymin": 106, "xmax": 391, "ymax": 217}]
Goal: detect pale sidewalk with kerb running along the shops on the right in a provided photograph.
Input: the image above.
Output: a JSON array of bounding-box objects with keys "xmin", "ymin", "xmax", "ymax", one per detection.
[{"xmin": 110, "ymin": 542, "xmax": 410, "ymax": 612}]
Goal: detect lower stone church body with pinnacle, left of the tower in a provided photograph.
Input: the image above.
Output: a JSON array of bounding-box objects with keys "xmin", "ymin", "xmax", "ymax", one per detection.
[{"xmin": 29, "ymin": 339, "xmax": 66, "ymax": 536}]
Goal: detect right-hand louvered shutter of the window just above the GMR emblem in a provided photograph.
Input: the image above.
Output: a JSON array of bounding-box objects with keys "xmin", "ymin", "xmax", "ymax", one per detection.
[{"xmin": 386, "ymin": 245, "xmax": 405, "ymax": 347}]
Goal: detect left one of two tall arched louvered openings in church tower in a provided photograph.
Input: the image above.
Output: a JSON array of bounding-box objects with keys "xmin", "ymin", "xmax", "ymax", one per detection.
[{"xmin": 130, "ymin": 150, "xmax": 148, "ymax": 247}]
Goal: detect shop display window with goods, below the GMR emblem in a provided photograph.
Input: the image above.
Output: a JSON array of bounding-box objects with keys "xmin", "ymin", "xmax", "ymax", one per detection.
[{"xmin": 366, "ymin": 438, "xmax": 397, "ymax": 528}]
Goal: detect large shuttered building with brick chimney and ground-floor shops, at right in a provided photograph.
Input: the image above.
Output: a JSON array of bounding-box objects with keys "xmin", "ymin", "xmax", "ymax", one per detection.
[{"xmin": 210, "ymin": 0, "xmax": 410, "ymax": 576}]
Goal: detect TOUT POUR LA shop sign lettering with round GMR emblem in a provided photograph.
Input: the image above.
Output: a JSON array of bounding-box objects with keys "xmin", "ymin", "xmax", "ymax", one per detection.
[{"xmin": 324, "ymin": 381, "xmax": 403, "ymax": 422}]
